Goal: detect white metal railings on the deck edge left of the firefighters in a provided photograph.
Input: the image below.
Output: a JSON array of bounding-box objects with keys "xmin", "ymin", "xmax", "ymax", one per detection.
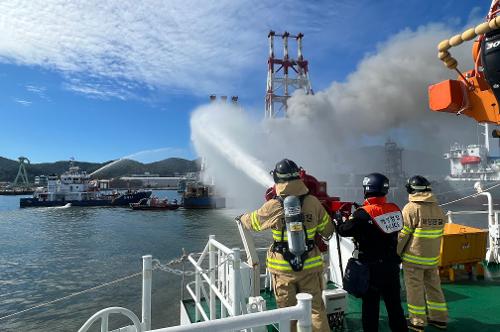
[{"xmin": 78, "ymin": 235, "xmax": 312, "ymax": 332}]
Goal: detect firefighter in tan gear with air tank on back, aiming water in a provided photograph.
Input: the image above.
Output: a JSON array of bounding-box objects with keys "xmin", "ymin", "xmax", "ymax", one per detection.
[{"xmin": 240, "ymin": 159, "xmax": 333, "ymax": 332}]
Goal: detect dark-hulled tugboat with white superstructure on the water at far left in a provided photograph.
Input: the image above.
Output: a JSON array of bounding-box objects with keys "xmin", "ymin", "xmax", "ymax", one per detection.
[{"xmin": 19, "ymin": 161, "xmax": 152, "ymax": 207}]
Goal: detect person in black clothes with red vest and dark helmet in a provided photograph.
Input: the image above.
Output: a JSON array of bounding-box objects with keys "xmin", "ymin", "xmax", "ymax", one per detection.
[{"xmin": 336, "ymin": 173, "xmax": 408, "ymax": 332}]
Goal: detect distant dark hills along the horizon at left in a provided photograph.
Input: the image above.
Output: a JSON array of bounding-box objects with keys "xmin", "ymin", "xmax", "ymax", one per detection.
[{"xmin": 0, "ymin": 157, "xmax": 199, "ymax": 181}]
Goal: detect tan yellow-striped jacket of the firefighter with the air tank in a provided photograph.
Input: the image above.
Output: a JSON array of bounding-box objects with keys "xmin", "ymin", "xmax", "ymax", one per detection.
[{"xmin": 241, "ymin": 180, "xmax": 333, "ymax": 275}]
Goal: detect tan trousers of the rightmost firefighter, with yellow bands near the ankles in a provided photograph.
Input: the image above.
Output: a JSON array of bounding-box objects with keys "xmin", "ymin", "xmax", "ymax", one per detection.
[{"xmin": 403, "ymin": 263, "xmax": 448, "ymax": 326}]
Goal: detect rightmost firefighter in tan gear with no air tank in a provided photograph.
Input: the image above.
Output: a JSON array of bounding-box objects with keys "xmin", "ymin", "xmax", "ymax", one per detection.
[{"xmin": 398, "ymin": 175, "xmax": 448, "ymax": 331}]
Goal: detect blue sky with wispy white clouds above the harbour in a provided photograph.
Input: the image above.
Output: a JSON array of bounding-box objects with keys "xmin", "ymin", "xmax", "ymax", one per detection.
[{"xmin": 0, "ymin": 0, "xmax": 490, "ymax": 162}]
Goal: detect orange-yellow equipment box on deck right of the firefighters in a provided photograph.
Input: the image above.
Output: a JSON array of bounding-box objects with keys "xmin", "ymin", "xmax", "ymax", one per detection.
[{"xmin": 439, "ymin": 224, "xmax": 488, "ymax": 266}]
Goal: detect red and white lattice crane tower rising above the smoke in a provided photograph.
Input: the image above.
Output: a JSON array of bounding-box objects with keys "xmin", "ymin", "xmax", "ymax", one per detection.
[{"xmin": 266, "ymin": 30, "xmax": 313, "ymax": 118}]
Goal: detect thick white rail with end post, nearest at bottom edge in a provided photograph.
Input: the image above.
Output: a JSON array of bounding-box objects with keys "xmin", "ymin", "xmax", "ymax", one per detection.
[{"xmin": 151, "ymin": 293, "xmax": 312, "ymax": 332}]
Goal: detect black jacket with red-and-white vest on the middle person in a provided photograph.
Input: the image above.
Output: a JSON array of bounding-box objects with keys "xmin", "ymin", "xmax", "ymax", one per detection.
[{"xmin": 337, "ymin": 197, "xmax": 403, "ymax": 264}]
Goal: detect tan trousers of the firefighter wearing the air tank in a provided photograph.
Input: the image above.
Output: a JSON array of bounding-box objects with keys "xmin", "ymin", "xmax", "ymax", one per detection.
[{"xmin": 272, "ymin": 272, "xmax": 330, "ymax": 332}]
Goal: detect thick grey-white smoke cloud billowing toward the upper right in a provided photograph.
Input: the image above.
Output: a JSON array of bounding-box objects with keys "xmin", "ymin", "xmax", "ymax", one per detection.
[{"xmin": 289, "ymin": 25, "xmax": 475, "ymax": 149}]
